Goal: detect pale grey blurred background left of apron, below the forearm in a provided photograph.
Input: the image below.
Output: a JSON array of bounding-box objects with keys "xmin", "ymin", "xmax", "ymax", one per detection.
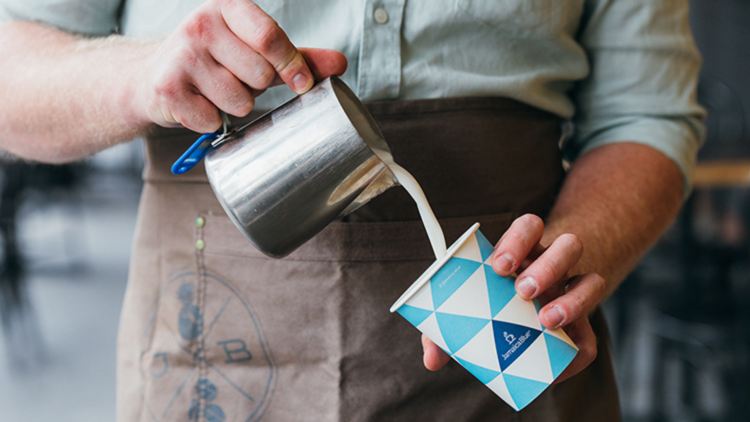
[{"xmin": 0, "ymin": 141, "xmax": 143, "ymax": 422}]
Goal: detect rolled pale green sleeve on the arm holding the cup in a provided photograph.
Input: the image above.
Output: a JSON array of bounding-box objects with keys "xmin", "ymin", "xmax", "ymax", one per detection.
[{"xmin": 563, "ymin": 0, "xmax": 705, "ymax": 196}]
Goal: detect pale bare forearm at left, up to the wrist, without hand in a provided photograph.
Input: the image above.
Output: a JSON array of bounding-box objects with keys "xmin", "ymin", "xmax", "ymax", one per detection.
[{"xmin": 0, "ymin": 22, "xmax": 156, "ymax": 162}]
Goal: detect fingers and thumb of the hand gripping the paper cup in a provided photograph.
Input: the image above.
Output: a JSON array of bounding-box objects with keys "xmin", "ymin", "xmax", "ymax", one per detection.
[{"xmin": 422, "ymin": 214, "xmax": 606, "ymax": 382}]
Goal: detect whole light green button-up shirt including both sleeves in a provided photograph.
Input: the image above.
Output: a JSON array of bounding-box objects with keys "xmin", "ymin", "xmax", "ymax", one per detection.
[{"xmin": 0, "ymin": 0, "xmax": 704, "ymax": 192}]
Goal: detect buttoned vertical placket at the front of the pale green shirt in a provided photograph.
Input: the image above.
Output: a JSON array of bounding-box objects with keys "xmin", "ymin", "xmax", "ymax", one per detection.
[{"xmin": 357, "ymin": 0, "xmax": 406, "ymax": 101}]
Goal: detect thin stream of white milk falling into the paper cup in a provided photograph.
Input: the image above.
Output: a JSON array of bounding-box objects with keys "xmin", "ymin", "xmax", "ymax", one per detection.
[{"xmin": 374, "ymin": 149, "xmax": 447, "ymax": 259}]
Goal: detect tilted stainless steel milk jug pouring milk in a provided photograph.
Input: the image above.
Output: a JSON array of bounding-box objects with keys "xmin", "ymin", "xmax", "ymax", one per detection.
[{"xmin": 175, "ymin": 76, "xmax": 397, "ymax": 258}]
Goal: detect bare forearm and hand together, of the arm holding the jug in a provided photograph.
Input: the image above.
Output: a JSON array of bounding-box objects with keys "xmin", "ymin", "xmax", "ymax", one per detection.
[{"xmin": 0, "ymin": 4, "xmax": 346, "ymax": 166}]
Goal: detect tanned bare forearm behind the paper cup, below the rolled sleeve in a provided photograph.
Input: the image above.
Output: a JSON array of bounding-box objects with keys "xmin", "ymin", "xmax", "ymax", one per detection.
[{"xmin": 542, "ymin": 143, "xmax": 683, "ymax": 296}]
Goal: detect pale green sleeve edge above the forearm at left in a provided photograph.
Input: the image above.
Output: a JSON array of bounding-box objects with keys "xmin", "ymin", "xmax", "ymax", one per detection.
[{"xmin": 0, "ymin": 0, "xmax": 122, "ymax": 36}]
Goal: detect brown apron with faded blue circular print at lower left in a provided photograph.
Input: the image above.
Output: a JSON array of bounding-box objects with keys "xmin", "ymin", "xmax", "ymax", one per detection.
[{"xmin": 117, "ymin": 98, "xmax": 620, "ymax": 422}]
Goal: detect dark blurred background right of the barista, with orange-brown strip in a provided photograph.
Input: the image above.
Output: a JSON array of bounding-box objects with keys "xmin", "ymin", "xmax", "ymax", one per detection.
[{"xmin": 606, "ymin": 0, "xmax": 750, "ymax": 422}]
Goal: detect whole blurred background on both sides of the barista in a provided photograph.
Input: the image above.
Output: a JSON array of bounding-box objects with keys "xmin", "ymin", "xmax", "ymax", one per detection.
[{"xmin": 0, "ymin": 0, "xmax": 750, "ymax": 422}]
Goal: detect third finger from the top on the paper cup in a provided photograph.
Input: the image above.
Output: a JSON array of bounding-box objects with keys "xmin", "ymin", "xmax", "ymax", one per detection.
[{"xmin": 539, "ymin": 273, "xmax": 607, "ymax": 329}]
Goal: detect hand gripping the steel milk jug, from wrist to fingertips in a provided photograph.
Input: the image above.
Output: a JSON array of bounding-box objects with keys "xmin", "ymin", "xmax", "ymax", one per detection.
[{"xmin": 132, "ymin": 0, "xmax": 346, "ymax": 132}]
